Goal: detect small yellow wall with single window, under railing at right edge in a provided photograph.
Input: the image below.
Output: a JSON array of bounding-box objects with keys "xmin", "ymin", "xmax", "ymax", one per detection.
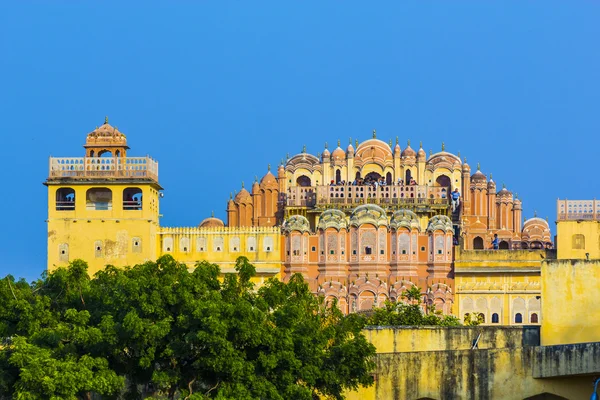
[{"xmin": 556, "ymin": 221, "xmax": 600, "ymax": 259}]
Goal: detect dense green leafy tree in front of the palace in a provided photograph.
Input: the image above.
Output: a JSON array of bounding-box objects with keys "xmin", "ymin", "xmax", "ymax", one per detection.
[{"xmin": 0, "ymin": 256, "xmax": 375, "ymax": 399}]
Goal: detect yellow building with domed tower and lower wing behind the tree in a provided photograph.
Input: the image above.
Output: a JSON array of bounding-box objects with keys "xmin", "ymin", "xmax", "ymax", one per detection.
[{"xmin": 44, "ymin": 118, "xmax": 282, "ymax": 282}]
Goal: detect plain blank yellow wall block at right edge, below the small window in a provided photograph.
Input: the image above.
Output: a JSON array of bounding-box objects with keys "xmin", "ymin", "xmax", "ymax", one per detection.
[{"xmin": 542, "ymin": 260, "xmax": 600, "ymax": 346}]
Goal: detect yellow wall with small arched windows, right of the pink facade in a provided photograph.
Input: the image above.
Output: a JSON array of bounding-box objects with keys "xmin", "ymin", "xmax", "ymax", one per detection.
[{"xmin": 454, "ymin": 247, "xmax": 554, "ymax": 325}]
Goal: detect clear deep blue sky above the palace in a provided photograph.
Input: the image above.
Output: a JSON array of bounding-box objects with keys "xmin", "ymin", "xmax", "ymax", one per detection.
[{"xmin": 0, "ymin": 0, "xmax": 600, "ymax": 279}]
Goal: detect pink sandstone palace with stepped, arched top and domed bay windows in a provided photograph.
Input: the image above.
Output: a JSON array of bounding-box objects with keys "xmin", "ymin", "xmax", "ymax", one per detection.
[{"xmin": 200, "ymin": 131, "xmax": 552, "ymax": 313}]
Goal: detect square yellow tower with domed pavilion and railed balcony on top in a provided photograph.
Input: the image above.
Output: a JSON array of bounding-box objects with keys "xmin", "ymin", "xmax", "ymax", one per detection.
[{"xmin": 44, "ymin": 118, "xmax": 162, "ymax": 274}]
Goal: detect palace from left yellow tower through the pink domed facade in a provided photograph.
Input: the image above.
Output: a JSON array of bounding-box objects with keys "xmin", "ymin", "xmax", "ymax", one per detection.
[{"xmin": 45, "ymin": 120, "xmax": 552, "ymax": 322}]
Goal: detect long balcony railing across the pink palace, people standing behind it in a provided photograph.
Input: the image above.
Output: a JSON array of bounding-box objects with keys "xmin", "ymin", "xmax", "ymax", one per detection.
[{"xmin": 283, "ymin": 185, "xmax": 450, "ymax": 207}]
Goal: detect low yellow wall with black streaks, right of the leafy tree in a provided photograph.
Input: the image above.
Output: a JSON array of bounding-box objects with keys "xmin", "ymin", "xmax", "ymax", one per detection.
[{"xmin": 346, "ymin": 327, "xmax": 593, "ymax": 400}]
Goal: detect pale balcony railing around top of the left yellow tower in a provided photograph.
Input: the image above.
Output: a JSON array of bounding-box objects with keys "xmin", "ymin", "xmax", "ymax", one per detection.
[{"xmin": 48, "ymin": 157, "xmax": 158, "ymax": 182}]
